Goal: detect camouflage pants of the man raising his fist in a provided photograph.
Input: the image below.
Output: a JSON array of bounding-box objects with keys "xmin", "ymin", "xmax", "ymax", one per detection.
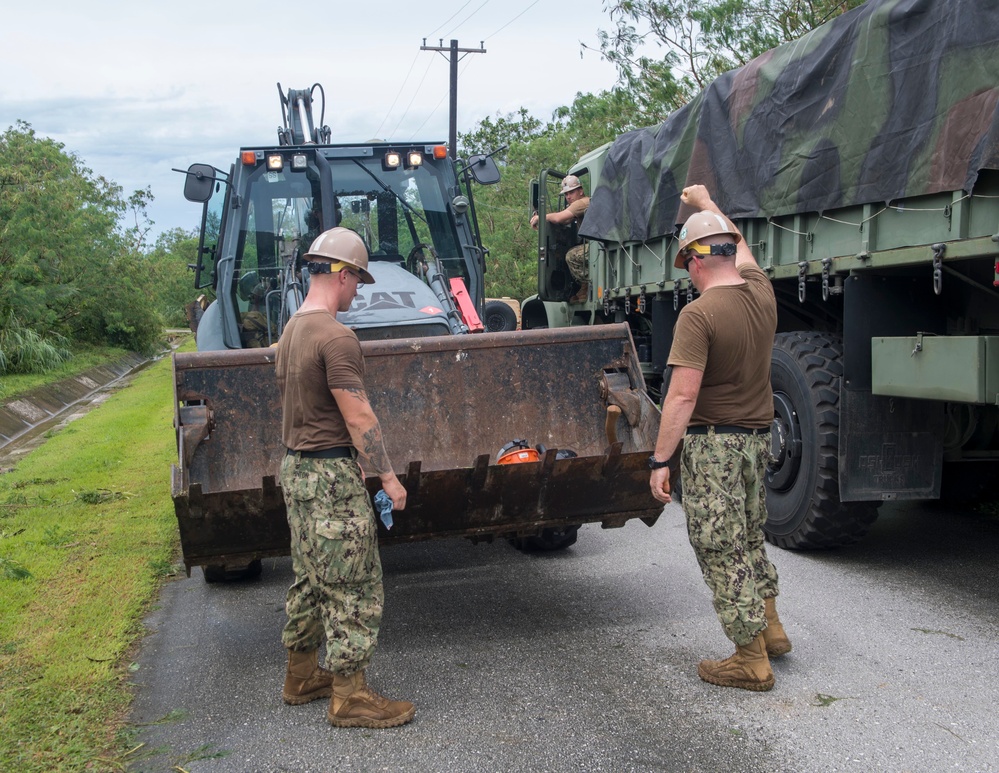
[{"xmin": 680, "ymin": 430, "xmax": 778, "ymax": 644}]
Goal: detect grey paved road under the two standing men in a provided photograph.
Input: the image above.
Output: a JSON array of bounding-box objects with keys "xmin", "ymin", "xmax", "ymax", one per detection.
[{"xmin": 132, "ymin": 503, "xmax": 999, "ymax": 773}]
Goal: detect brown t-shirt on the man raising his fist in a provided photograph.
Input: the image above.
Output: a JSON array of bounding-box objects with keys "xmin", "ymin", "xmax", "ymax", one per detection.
[{"xmin": 669, "ymin": 264, "xmax": 777, "ymax": 428}]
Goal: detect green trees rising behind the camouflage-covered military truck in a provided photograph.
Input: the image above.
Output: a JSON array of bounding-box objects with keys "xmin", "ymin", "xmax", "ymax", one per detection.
[{"xmin": 459, "ymin": 0, "xmax": 862, "ymax": 298}]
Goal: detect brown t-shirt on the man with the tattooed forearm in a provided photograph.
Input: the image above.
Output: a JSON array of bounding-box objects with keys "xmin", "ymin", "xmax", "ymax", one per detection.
[{"xmin": 276, "ymin": 310, "xmax": 364, "ymax": 451}]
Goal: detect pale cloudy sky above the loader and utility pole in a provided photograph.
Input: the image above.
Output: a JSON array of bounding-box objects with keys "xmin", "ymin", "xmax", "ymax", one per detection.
[{"xmin": 0, "ymin": 0, "xmax": 615, "ymax": 241}]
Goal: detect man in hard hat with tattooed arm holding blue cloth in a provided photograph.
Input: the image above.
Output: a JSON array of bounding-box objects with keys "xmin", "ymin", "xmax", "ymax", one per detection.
[{"xmin": 275, "ymin": 228, "xmax": 415, "ymax": 728}]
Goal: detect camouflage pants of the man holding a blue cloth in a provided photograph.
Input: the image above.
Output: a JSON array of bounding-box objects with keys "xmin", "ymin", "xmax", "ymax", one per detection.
[{"xmin": 281, "ymin": 455, "xmax": 384, "ymax": 674}]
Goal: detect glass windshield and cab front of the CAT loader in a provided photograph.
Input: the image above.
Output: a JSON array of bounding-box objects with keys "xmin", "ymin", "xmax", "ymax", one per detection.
[{"xmin": 224, "ymin": 146, "xmax": 480, "ymax": 348}]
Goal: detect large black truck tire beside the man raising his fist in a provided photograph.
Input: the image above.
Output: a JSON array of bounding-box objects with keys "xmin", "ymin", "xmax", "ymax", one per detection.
[{"xmin": 764, "ymin": 332, "xmax": 879, "ymax": 550}]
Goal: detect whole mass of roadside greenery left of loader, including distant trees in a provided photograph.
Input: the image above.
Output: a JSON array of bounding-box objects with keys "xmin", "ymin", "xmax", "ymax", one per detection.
[{"xmin": 0, "ymin": 121, "xmax": 197, "ymax": 378}]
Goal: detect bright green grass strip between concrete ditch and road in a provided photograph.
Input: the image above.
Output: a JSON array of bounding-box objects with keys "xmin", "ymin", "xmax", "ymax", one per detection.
[{"xmin": 0, "ymin": 340, "xmax": 189, "ymax": 771}]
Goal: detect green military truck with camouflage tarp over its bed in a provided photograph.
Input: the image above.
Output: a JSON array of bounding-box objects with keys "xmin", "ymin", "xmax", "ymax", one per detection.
[{"xmin": 522, "ymin": 0, "xmax": 999, "ymax": 548}]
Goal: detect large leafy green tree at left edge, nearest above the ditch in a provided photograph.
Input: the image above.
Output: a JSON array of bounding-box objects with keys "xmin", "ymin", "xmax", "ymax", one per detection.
[{"xmin": 0, "ymin": 121, "xmax": 161, "ymax": 362}]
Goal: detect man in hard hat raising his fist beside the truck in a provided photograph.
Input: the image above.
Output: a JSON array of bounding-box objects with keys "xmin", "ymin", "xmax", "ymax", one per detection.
[{"xmin": 649, "ymin": 185, "xmax": 791, "ymax": 691}]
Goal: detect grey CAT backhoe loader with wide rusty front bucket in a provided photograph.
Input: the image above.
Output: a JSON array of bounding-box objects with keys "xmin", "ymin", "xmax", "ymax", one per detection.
[{"xmin": 172, "ymin": 84, "xmax": 661, "ymax": 581}]
